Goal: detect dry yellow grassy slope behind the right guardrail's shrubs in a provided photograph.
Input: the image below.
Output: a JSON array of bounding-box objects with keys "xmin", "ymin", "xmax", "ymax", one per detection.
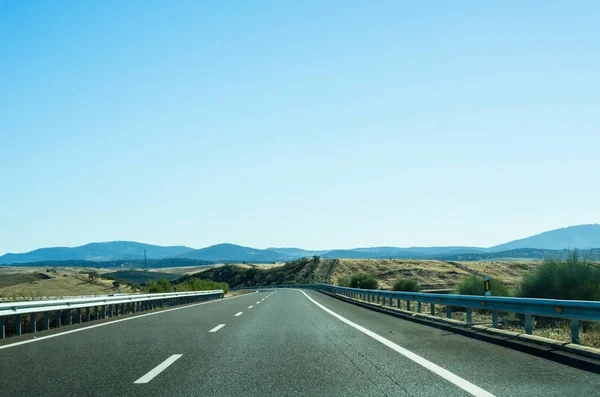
[{"xmin": 331, "ymin": 259, "xmax": 541, "ymax": 290}]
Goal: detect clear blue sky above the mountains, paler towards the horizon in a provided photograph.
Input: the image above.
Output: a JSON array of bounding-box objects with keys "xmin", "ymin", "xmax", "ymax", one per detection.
[{"xmin": 0, "ymin": 0, "xmax": 600, "ymax": 254}]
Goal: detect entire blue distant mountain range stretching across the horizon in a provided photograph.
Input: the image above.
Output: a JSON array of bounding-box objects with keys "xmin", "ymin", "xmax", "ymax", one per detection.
[{"xmin": 0, "ymin": 224, "xmax": 600, "ymax": 264}]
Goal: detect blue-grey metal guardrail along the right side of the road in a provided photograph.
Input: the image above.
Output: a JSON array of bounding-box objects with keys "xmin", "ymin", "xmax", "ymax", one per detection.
[{"xmin": 254, "ymin": 284, "xmax": 600, "ymax": 344}]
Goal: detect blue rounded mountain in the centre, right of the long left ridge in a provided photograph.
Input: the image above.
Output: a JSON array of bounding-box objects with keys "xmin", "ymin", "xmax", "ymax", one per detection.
[{"xmin": 180, "ymin": 243, "xmax": 291, "ymax": 263}]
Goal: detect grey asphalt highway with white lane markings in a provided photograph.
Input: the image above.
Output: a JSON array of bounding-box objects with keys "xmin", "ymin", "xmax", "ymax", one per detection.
[{"xmin": 0, "ymin": 289, "xmax": 600, "ymax": 397}]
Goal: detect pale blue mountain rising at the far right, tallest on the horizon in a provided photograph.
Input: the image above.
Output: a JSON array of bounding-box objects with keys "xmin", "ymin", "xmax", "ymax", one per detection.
[{"xmin": 490, "ymin": 224, "xmax": 600, "ymax": 251}]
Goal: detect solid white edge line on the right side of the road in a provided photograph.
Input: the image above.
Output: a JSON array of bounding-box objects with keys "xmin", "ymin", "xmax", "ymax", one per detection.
[{"xmin": 296, "ymin": 290, "xmax": 494, "ymax": 397}]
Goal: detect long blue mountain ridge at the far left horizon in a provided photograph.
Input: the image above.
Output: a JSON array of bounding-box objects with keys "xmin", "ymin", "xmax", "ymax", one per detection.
[{"xmin": 0, "ymin": 241, "xmax": 193, "ymax": 264}]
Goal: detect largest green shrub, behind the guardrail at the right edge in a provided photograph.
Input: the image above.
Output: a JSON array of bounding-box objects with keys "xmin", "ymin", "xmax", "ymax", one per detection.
[{"xmin": 518, "ymin": 251, "xmax": 600, "ymax": 301}]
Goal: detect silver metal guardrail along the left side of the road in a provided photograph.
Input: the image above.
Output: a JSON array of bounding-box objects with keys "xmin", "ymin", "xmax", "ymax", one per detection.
[{"xmin": 0, "ymin": 290, "xmax": 224, "ymax": 339}]
